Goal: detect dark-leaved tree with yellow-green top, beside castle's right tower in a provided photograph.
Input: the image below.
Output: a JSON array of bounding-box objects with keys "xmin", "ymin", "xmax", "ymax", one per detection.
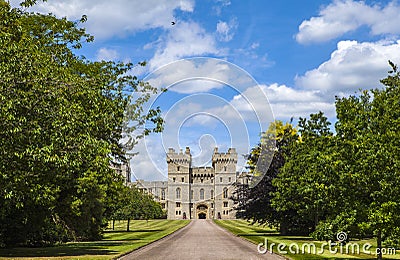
[{"xmin": 233, "ymin": 121, "xmax": 298, "ymax": 233}]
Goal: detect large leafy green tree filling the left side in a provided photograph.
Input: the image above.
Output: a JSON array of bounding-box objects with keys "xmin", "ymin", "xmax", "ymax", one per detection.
[{"xmin": 0, "ymin": 0, "xmax": 162, "ymax": 245}]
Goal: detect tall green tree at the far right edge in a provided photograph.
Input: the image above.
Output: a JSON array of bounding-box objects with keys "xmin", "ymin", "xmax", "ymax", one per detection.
[{"xmin": 336, "ymin": 62, "xmax": 400, "ymax": 259}]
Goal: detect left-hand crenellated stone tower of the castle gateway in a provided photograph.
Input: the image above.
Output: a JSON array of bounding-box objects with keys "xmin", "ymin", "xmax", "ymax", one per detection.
[{"xmin": 167, "ymin": 147, "xmax": 192, "ymax": 219}]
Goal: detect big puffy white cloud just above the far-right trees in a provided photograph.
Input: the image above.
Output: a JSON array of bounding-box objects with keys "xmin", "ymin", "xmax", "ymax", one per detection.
[{"xmin": 296, "ymin": 41, "xmax": 400, "ymax": 95}]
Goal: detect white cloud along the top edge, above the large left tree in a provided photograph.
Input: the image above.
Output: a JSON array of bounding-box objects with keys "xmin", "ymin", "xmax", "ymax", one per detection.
[{"xmin": 11, "ymin": 0, "xmax": 194, "ymax": 39}]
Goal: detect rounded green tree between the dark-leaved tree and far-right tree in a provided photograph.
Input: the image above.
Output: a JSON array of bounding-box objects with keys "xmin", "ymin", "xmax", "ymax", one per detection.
[{"xmin": 272, "ymin": 112, "xmax": 336, "ymax": 235}]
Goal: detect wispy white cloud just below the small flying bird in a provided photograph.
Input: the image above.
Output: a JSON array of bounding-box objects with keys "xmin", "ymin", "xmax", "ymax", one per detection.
[{"xmin": 149, "ymin": 21, "xmax": 221, "ymax": 69}]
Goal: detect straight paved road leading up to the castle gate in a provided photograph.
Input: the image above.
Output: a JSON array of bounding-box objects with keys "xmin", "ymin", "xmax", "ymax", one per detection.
[{"xmin": 122, "ymin": 220, "xmax": 284, "ymax": 260}]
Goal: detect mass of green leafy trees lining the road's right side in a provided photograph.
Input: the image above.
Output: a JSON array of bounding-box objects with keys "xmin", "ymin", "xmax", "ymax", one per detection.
[{"xmin": 244, "ymin": 62, "xmax": 400, "ymax": 259}]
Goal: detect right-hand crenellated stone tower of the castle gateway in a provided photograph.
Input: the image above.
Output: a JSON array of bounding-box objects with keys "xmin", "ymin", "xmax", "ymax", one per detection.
[{"xmin": 212, "ymin": 148, "xmax": 237, "ymax": 219}]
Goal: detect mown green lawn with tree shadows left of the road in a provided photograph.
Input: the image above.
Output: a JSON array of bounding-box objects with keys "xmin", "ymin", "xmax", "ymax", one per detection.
[{"xmin": 0, "ymin": 220, "xmax": 189, "ymax": 259}]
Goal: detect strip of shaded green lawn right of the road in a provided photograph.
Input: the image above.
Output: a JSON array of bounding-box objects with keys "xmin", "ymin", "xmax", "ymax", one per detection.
[{"xmin": 215, "ymin": 220, "xmax": 400, "ymax": 260}]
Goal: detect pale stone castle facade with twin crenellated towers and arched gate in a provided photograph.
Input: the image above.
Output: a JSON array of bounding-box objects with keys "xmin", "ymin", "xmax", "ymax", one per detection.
[{"xmin": 136, "ymin": 147, "xmax": 238, "ymax": 219}]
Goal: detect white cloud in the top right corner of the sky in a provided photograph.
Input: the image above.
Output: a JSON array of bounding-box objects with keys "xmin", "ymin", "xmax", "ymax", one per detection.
[{"xmin": 296, "ymin": 0, "xmax": 400, "ymax": 43}]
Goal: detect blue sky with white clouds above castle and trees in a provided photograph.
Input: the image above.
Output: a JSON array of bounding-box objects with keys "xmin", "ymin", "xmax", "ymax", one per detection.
[{"xmin": 11, "ymin": 0, "xmax": 400, "ymax": 179}]
